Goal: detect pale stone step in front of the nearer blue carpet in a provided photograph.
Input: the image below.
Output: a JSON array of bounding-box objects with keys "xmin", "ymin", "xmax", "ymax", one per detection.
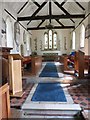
[{"xmin": 22, "ymin": 103, "xmax": 81, "ymax": 115}]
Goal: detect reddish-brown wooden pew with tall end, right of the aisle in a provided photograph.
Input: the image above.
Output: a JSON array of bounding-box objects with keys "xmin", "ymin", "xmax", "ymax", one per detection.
[{"xmin": 64, "ymin": 50, "xmax": 90, "ymax": 79}]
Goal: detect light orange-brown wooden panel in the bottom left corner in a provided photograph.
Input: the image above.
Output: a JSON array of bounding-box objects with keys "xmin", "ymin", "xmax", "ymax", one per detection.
[{"xmin": 0, "ymin": 83, "xmax": 10, "ymax": 120}]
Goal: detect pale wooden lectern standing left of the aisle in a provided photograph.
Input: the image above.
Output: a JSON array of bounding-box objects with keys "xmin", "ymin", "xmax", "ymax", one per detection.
[{"xmin": 8, "ymin": 54, "xmax": 23, "ymax": 97}]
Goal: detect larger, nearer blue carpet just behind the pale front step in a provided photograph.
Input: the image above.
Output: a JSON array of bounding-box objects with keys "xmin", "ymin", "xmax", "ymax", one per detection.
[{"xmin": 31, "ymin": 83, "xmax": 67, "ymax": 102}]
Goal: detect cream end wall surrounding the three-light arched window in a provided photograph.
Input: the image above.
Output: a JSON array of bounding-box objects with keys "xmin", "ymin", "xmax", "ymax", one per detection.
[{"xmin": 32, "ymin": 30, "xmax": 70, "ymax": 55}]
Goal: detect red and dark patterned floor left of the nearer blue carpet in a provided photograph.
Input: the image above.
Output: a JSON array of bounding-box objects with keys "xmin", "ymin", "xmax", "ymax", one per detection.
[{"xmin": 10, "ymin": 80, "xmax": 34, "ymax": 109}]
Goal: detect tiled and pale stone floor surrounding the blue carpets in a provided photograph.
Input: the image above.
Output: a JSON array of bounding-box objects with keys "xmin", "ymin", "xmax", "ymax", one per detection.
[{"xmin": 11, "ymin": 63, "xmax": 90, "ymax": 119}]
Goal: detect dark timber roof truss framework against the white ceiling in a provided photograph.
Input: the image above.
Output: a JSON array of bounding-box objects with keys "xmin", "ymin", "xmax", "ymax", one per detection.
[{"xmin": 17, "ymin": 0, "xmax": 85, "ymax": 30}]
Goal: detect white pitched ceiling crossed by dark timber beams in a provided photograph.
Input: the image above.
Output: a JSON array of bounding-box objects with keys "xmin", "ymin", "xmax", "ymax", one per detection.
[{"xmin": 4, "ymin": 0, "xmax": 89, "ymax": 30}]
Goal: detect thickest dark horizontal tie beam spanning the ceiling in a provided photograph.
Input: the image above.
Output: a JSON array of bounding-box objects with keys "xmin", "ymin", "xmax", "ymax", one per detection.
[{"xmin": 17, "ymin": 14, "xmax": 85, "ymax": 21}]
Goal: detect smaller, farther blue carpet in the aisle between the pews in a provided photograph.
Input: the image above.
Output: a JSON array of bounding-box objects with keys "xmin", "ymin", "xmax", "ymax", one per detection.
[{"xmin": 39, "ymin": 63, "xmax": 59, "ymax": 77}]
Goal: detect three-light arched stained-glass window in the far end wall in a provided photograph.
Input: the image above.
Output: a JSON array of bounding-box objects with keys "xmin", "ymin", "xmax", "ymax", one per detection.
[{"xmin": 44, "ymin": 30, "xmax": 57, "ymax": 50}]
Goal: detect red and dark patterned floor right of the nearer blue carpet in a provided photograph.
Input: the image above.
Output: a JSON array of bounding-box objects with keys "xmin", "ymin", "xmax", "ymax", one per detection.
[{"xmin": 68, "ymin": 84, "xmax": 90, "ymax": 110}]
